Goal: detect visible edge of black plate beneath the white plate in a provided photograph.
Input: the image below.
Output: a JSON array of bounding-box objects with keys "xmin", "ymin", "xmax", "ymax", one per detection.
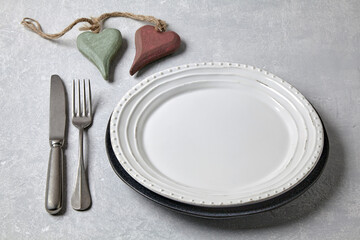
[{"xmin": 105, "ymin": 116, "xmax": 329, "ymax": 218}]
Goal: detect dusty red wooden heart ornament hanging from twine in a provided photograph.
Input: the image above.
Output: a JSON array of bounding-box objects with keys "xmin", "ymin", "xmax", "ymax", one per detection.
[{"xmin": 130, "ymin": 25, "xmax": 181, "ymax": 75}]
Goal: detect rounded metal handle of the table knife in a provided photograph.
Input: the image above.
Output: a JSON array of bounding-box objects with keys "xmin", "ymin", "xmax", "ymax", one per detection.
[{"xmin": 45, "ymin": 142, "xmax": 63, "ymax": 214}]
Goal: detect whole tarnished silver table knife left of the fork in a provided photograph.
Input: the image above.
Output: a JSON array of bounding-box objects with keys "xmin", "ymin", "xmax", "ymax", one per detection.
[{"xmin": 45, "ymin": 75, "xmax": 66, "ymax": 214}]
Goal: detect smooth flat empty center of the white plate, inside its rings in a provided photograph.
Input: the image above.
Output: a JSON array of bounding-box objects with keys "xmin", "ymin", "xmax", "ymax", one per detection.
[{"xmin": 138, "ymin": 86, "xmax": 298, "ymax": 192}]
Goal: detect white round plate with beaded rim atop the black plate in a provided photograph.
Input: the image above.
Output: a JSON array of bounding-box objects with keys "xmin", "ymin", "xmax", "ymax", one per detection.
[{"xmin": 110, "ymin": 63, "xmax": 324, "ymax": 207}]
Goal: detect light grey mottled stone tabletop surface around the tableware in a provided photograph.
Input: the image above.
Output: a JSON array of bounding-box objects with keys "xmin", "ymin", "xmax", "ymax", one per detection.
[{"xmin": 0, "ymin": 0, "xmax": 360, "ymax": 239}]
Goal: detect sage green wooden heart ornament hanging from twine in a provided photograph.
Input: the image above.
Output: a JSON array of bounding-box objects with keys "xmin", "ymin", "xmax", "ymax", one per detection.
[{"xmin": 76, "ymin": 28, "xmax": 122, "ymax": 80}]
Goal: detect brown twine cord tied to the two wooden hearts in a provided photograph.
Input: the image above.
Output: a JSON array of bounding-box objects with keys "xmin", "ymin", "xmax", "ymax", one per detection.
[{"xmin": 21, "ymin": 12, "xmax": 167, "ymax": 39}]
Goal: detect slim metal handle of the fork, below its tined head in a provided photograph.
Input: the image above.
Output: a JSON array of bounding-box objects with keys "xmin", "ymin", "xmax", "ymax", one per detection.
[{"xmin": 71, "ymin": 128, "xmax": 91, "ymax": 211}]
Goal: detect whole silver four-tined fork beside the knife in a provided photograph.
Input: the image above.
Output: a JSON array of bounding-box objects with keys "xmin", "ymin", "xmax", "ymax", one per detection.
[{"xmin": 71, "ymin": 80, "xmax": 92, "ymax": 210}]
